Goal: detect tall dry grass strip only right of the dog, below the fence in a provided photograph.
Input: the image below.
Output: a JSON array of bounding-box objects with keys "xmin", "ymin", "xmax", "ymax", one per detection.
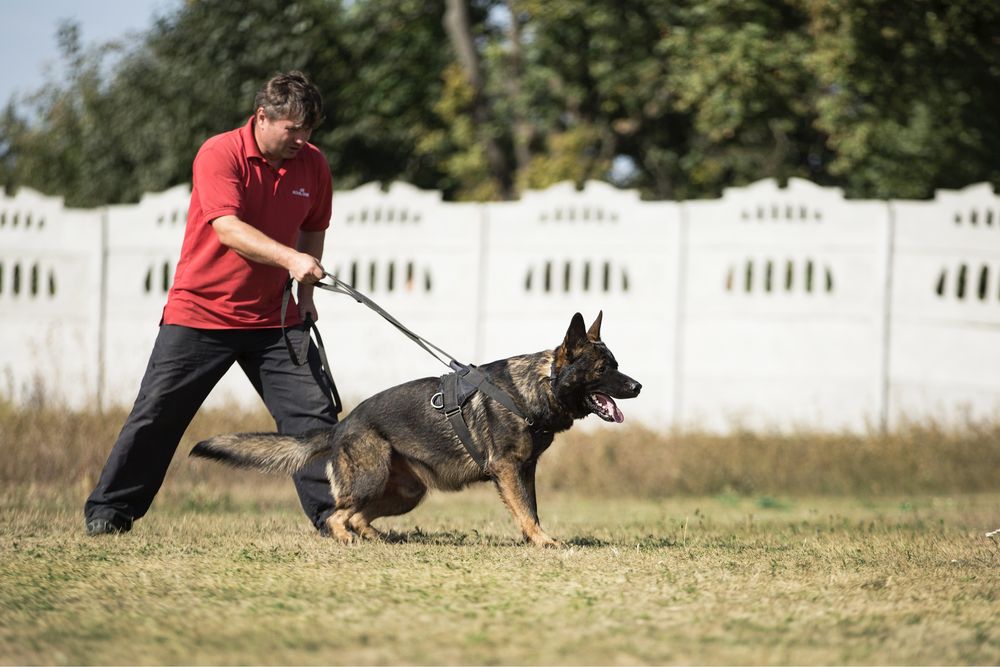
[{"xmin": 542, "ymin": 423, "xmax": 1000, "ymax": 496}]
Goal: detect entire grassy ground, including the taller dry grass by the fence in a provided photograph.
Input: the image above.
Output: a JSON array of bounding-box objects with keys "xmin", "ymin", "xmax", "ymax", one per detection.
[{"xmin": 0, "ymin": 409, "xmax": 1000, "ymax": 664}]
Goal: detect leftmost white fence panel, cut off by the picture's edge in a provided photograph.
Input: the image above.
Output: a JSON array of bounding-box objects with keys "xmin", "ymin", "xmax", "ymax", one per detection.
[{"xmin": 0, "ymin": 190, "xmax": 103, "ymax": 404}]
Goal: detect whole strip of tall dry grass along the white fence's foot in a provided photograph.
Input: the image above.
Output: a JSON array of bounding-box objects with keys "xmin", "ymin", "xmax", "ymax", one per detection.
[{"xmin": 0, "ymin": 403, "xmax": 1000, "ymax": 497}]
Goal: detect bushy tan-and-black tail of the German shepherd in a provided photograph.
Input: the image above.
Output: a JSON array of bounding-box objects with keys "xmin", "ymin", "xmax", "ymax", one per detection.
[{"xmin": 190, "ymin": 427, "xmax": 336, "ymax": 475}]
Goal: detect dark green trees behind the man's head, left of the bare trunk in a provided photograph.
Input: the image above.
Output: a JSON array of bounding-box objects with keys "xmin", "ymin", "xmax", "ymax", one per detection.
[{"xmin": 0, "ymin": 0, "xmax": 448, "ymax": 206}]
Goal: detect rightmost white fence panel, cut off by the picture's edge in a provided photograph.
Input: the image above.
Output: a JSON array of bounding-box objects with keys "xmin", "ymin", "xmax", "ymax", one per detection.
[{"xmin": 888, "ymin": 184, "xmax": 1000, "ymax": 423}]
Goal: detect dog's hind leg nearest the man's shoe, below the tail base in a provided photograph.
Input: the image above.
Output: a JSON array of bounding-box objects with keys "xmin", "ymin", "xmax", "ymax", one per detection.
[{"xmin": 326, "ymin": 432, "xmax": 392, "ymax": 543}]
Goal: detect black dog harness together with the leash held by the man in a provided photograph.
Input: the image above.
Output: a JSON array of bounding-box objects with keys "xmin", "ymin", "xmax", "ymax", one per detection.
[{"xmin": 281, "ymin": 273, "xmax": 534, "ymax": 473}]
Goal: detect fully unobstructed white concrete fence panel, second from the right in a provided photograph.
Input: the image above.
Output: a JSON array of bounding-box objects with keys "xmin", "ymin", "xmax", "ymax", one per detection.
[{"xmin": 680, "ymin": 179, "xmax": 889, "ymax": 429}]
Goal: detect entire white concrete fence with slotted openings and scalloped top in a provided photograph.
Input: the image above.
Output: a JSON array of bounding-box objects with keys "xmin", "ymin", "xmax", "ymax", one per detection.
[{"xmin": 0, "ymin": 179, "xmax": 1000, "ymax": 431}]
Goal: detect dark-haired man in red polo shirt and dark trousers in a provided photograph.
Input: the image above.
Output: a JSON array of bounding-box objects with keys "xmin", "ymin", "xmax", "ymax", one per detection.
[{"xmin": 84, "ymin": 72, "xmax": 337, "ymax": 535}]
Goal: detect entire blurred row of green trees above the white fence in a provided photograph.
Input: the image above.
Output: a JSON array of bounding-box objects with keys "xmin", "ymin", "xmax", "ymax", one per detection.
[{"xmin": 0, "ymin": 0, "xmax": 1000, "ymax": 206}]
